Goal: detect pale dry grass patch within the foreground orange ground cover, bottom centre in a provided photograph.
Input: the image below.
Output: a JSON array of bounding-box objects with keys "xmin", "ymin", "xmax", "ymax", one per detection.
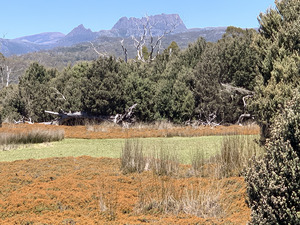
[{"xmin": 135, "ymin": 178, "xmax": 225, "ymax": 218}]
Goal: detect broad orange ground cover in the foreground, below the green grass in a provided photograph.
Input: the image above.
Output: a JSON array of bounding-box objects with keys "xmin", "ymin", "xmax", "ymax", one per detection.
[{"xmin": 0, "ymin": 156, "xmax": 250, "ymax": 224}]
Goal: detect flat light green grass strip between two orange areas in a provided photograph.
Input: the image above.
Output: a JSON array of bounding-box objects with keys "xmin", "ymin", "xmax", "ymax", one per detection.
[{"xmin": 0, "ymin": 135, "xmax": 257, "ymax": 164}]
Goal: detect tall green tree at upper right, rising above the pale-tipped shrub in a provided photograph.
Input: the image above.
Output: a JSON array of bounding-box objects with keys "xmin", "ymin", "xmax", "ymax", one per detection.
[{"xmin": 252, "ymin": 0, "xmax": 300, "ymax": 142}]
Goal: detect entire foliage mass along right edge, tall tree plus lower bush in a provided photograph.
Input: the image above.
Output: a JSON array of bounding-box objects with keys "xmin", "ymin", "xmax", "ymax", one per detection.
[{"xmin": 246, "ymin": 0, "xmax": 300, "ymax": 224}]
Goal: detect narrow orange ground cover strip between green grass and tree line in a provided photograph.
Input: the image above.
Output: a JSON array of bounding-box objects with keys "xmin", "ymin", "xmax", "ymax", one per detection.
[{"xmin": 0, "ymin": 124, "xmax": 259, "ymax": 139}]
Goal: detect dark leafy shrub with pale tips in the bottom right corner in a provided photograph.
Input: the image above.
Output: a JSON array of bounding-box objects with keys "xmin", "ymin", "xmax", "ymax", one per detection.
[{"xmin": 246, "ymin": 92, "xmax": 300, "ymax": 224}]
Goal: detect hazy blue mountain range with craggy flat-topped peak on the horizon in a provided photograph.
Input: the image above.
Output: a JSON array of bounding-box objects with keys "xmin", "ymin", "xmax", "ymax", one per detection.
[{"xmin": 0, "ymin": 14, "xmax": 226, "ymax": 56}]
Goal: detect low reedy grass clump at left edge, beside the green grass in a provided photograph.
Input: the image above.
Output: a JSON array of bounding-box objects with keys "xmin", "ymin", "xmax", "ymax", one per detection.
[{"xmin": 0, "ymin": 129, "xmax": 64, "ymax": 145}]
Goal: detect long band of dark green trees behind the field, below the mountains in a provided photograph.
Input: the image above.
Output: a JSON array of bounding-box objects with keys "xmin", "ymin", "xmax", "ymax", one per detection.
[{"xmin": 1, "ymin": 31, "xmax": 256, "ymax": 123}]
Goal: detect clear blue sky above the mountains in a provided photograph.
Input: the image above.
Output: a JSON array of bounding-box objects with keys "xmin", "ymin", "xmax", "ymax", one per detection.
[{"xmin": 0, "ymin": 0, "xmax": 275, "ymax": 39}]
